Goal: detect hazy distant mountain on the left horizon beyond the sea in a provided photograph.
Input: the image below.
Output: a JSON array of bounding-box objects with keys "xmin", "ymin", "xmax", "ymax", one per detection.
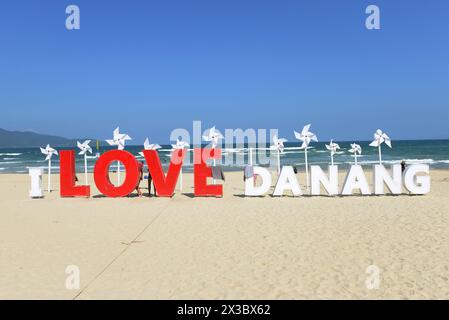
[{"xmin": 0, "ymin": 128, "xmax": 105, "ymax": 148}]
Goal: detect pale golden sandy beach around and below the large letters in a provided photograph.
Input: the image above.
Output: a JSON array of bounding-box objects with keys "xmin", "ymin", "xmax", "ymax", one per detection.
[{"xmin": 0, "ymin": 170, "xmax": 449, "ymax": 299}]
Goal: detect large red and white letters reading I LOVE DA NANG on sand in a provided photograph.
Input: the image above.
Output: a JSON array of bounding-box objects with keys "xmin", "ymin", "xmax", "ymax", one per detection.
[{"xmin": 30, "ymin": 148, "xmax": 430, "ymax": 198}]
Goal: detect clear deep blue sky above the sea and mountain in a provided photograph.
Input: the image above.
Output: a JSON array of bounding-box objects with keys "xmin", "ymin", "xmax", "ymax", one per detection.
[{"xmin": 0, "ymin": 0, "xmax": 449, "ymax": 143}]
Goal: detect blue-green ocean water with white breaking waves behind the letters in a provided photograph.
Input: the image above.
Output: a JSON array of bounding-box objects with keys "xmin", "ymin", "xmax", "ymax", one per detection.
[{"xmin": 0, "ymin": 140, "xmax": 449, "ymax": 174}]
